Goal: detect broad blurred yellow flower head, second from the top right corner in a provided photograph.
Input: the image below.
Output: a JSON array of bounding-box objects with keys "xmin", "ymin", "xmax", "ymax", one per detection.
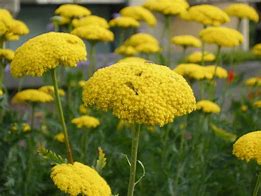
[{"xmin": 181, "ymin": 4, "xmax": 230, "ymax": 26}]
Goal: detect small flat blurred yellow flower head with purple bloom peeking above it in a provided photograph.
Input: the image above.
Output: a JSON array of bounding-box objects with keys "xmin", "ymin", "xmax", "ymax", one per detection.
[{"xmin": 109, "ymin": 16, "xmax": 140, "ymax": 28}]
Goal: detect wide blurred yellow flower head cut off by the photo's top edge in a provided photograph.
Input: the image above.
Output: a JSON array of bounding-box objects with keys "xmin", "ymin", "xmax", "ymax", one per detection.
[{"xmin": 144, "ymin": 0, "xmax": 189, "ymax": 15}]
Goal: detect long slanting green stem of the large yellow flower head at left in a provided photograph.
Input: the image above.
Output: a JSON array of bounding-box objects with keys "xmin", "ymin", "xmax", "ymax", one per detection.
[{"xmin": 51, "ymin": 69, "xmax": 73, "ymax": 164}]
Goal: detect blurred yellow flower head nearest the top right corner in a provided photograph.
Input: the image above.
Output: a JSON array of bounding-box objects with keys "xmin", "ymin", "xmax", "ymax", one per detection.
[{"xmin": 225, "ymin": 3, "xmax": 259, "ymax": 22}]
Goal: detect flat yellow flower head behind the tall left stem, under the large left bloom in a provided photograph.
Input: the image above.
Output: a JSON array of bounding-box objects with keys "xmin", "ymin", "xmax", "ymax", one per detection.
[{"xmin": 12, "ymin": 89, "xmax": 53, "ymax": 104}]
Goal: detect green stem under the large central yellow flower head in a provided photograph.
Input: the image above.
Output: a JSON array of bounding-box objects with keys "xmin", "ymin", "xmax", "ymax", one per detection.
[{"xmin": 128, "ymin": 125, "xmax": 141, "ymax": 196}]
